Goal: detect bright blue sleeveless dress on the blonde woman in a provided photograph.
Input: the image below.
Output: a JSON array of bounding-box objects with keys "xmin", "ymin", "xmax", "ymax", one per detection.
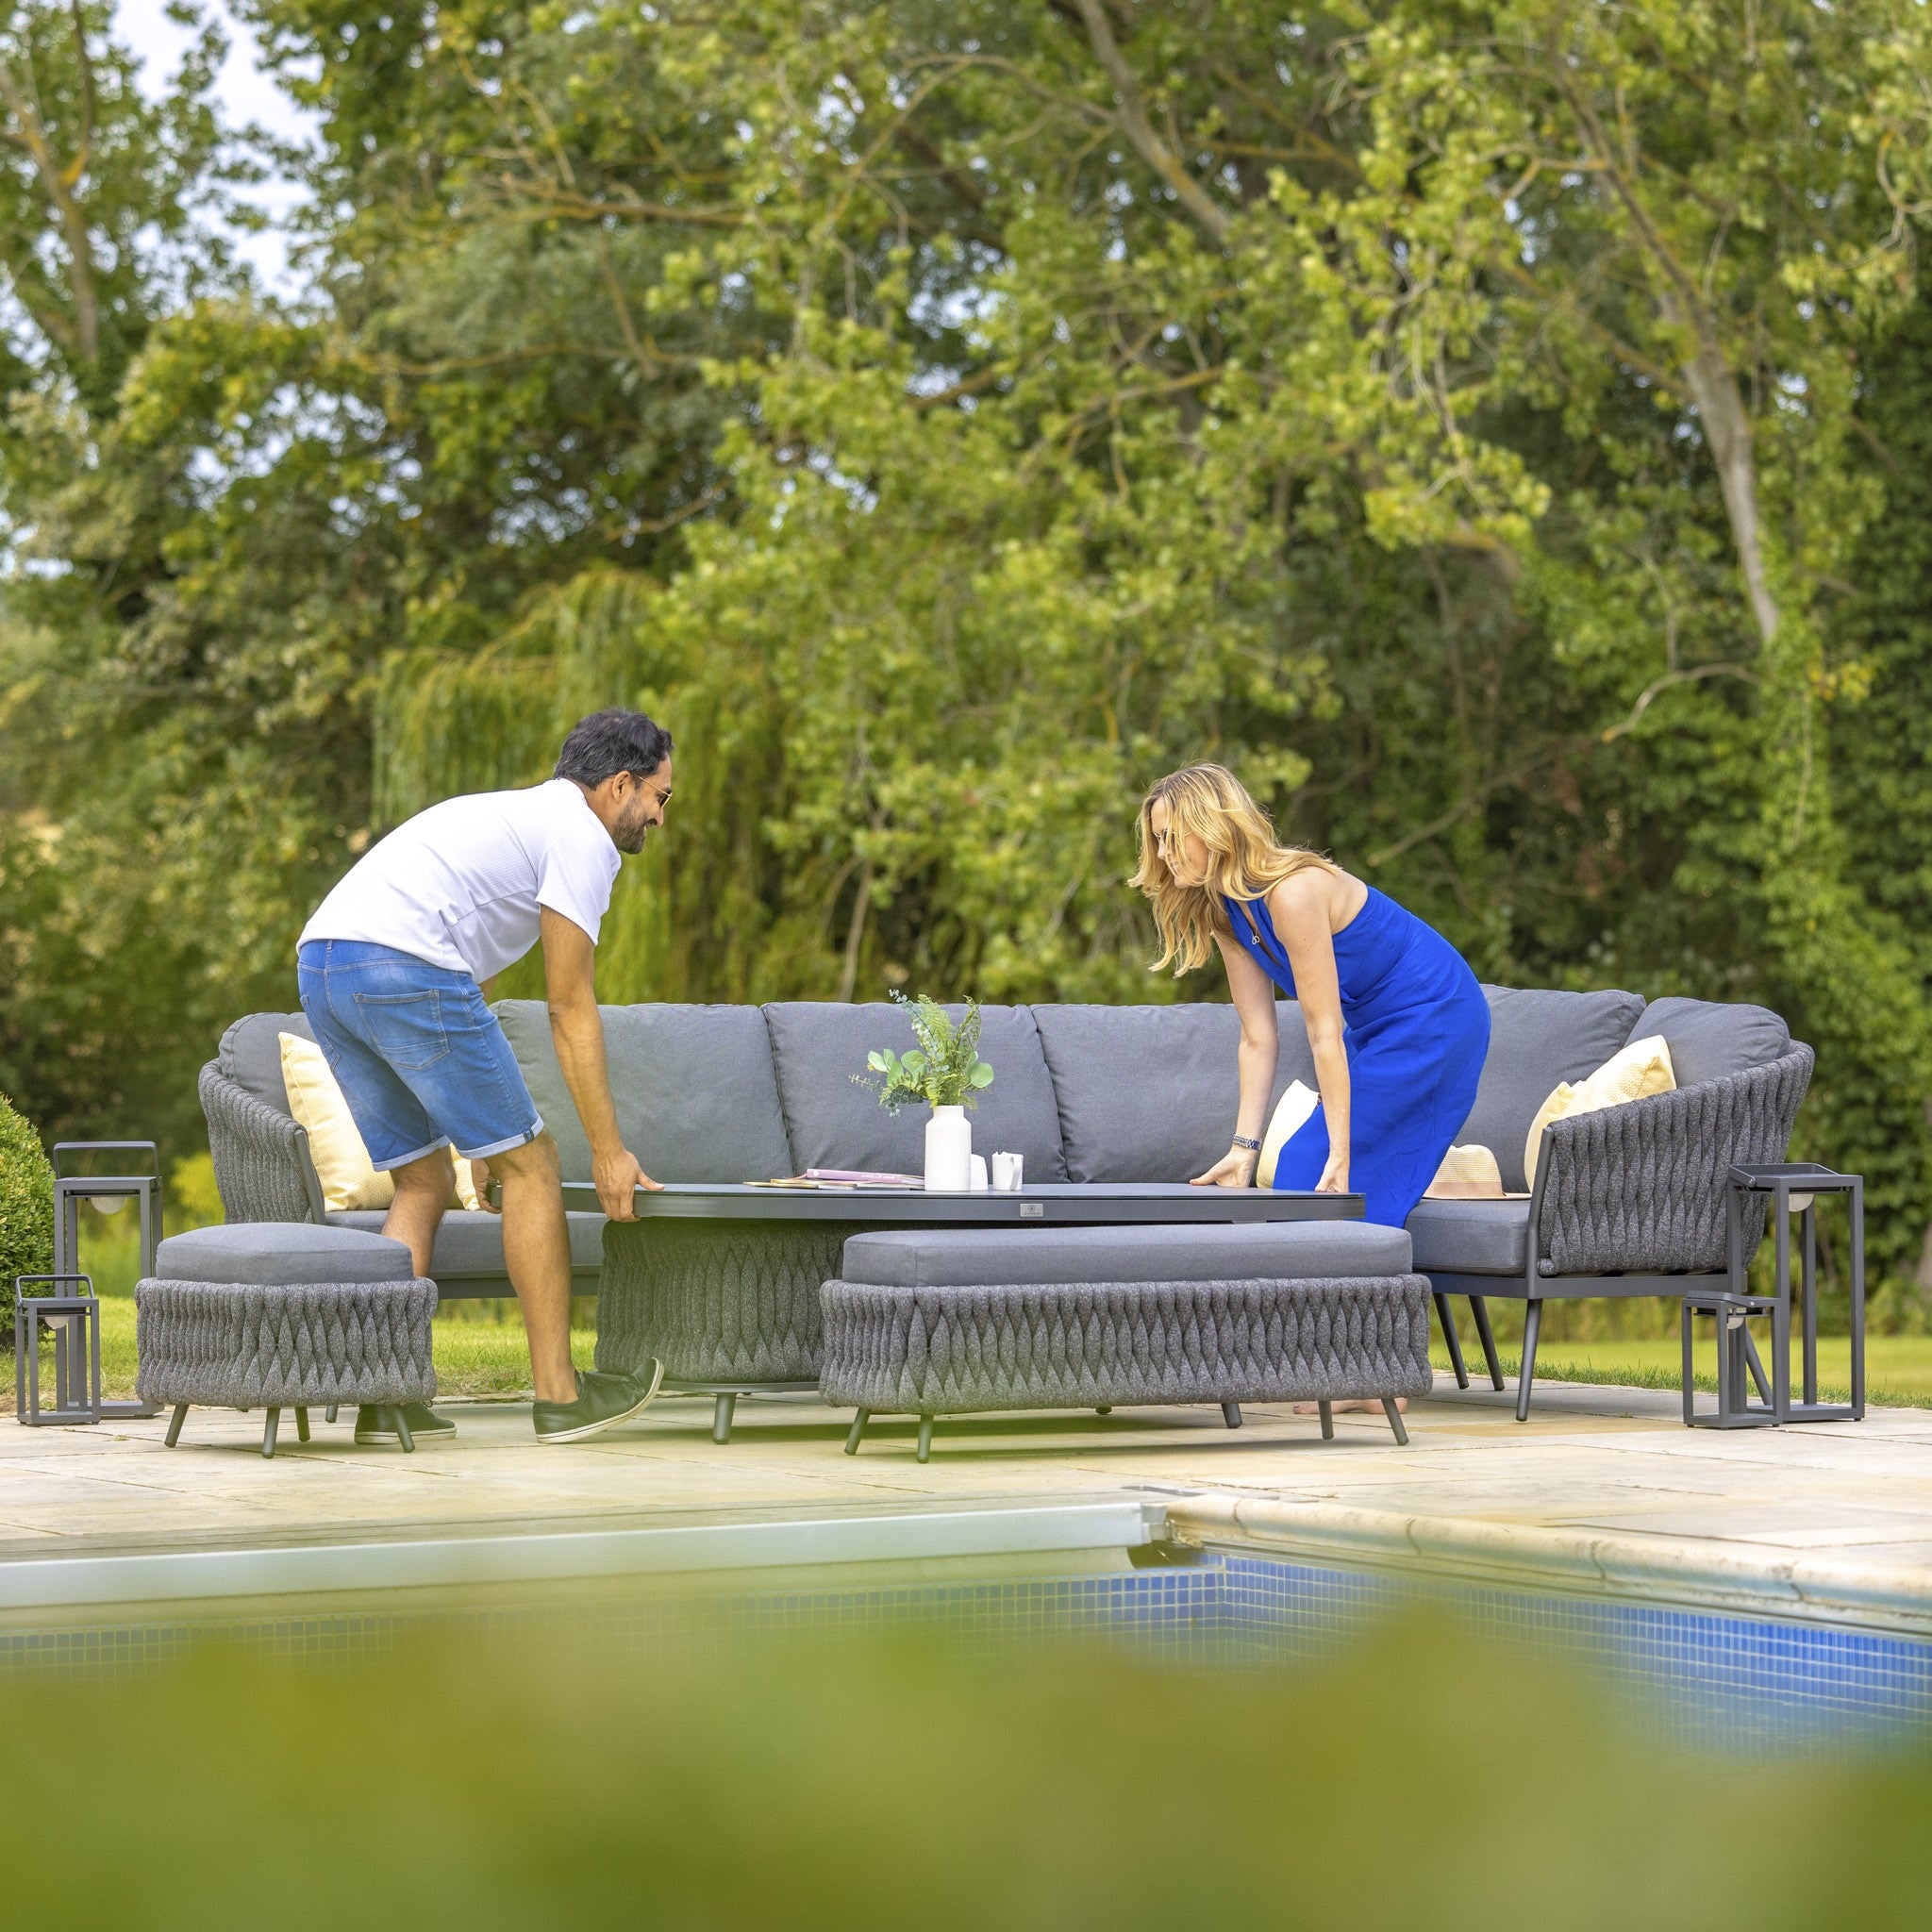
[{"xmin": 1224, "ymin": 887, "xmax": 1490, "ymax": 1226}]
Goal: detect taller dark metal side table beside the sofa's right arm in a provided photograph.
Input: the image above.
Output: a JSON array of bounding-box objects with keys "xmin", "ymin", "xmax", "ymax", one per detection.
[{"xmin": 1731, "ymin": 1161, "xmax": 1864, "ymax": 1422}]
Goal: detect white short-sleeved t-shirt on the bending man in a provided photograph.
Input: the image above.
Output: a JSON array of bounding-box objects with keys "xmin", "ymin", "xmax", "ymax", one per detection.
[{"xmin": 299, "ymin": 778, "xmax": 622, "ymax": 983}]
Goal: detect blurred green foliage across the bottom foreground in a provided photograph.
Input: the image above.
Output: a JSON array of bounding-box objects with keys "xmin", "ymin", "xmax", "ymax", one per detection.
[{"xmin": 0, "ymin": 1623, "xmax": 1932, "ymax": 1932}]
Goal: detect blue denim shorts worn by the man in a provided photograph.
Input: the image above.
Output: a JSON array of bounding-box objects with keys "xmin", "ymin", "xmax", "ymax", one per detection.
[{"xmin": 295, "ymin": 939, "xmax": 542, "ymax": 1167}]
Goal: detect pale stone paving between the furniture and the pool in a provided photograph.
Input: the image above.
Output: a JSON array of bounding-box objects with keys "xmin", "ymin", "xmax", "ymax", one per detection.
[{"xmin": 0, "ymin": 1375, "xmax": 1932, "ymax": 1637}]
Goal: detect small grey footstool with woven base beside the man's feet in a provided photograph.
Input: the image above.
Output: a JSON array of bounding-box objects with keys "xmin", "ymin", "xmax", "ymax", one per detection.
[{"xmin": 133, "ymin": 1221, "xmax": 437, "ymax": 1455}]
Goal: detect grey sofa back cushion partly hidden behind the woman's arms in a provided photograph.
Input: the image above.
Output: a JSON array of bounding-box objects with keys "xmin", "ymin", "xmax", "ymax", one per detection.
[{"xmin": 1034, "ymin": 999, "xmax": 1316, "ymax": 1180}]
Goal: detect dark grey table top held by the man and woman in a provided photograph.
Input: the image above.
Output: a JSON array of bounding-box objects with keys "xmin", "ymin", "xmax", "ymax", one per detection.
[{"xmin": 564, "ymin": 1180, "xmax": 1362, "ymax": 1229}]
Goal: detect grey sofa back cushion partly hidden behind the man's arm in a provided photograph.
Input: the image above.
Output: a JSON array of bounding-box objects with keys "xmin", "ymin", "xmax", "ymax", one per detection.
[{"xmin": 496, "ymin": 999, "xmax": 792, "ymax": 1180}]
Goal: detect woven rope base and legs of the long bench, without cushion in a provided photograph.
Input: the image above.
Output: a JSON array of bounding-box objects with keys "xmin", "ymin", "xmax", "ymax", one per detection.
[{"xmin": 819, "ymin": 1275, "xmax": 1432, "ymax": 1460}]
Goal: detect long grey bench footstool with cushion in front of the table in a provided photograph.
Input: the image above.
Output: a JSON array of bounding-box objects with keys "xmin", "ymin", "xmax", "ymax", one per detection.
[{"xmin": 819, "ymin": 1221, "xmax": 1432, "ymax": 1462}]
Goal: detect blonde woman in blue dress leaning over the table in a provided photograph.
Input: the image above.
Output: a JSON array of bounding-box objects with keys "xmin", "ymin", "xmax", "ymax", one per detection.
[{"xmin": 1134, "ymin": 765, "xmax": 1490, "ymax": 1226}]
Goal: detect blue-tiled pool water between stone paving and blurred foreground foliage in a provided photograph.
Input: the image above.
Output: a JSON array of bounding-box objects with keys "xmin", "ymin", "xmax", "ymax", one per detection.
[{"xmin": 0, "ymin": 1552, "xmax": 1932, "ymax": 1757}]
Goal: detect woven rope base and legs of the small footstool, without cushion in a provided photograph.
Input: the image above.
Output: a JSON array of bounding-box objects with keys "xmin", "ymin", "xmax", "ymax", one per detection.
[{"xmin": 133, "ymin": 1277, "xmax": 437, "ymax": 1455}]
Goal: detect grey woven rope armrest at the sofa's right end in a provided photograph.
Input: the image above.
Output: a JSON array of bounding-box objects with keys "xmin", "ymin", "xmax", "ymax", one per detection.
[{"xmin": 1534, "ymin": 1045, "xmax": 1814, "ymax": 1275}]
